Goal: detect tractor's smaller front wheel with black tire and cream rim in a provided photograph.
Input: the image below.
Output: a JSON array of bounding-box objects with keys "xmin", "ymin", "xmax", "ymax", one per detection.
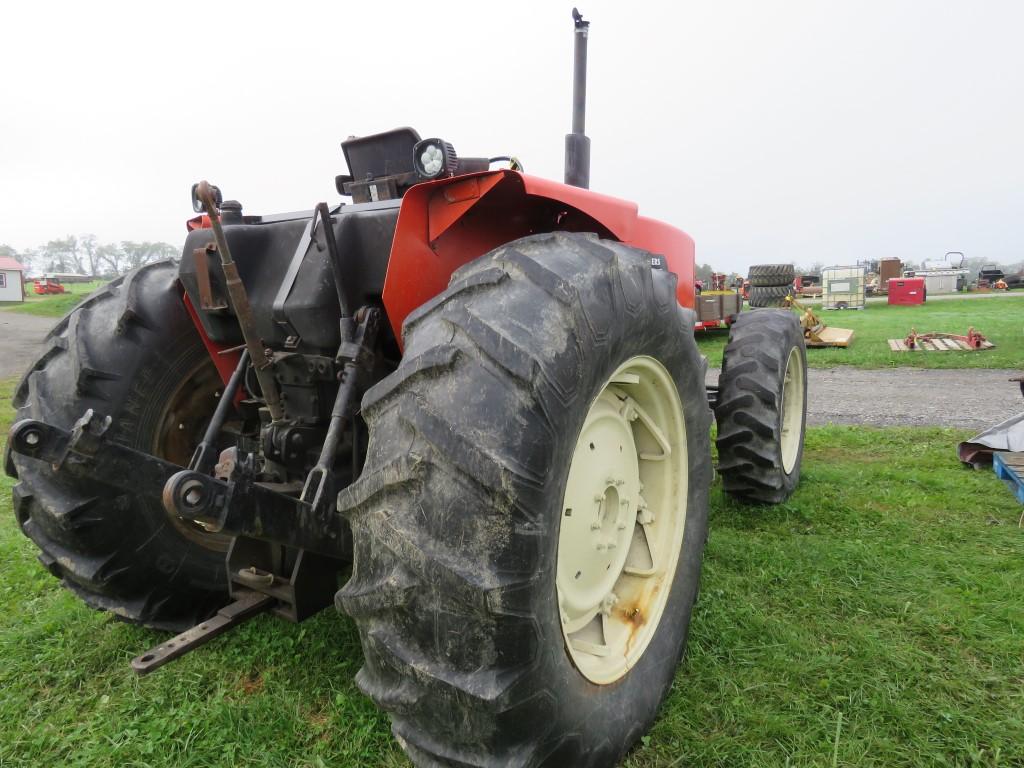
[{"xmin": 715, "ymin": 309, "xmax": 807, "ymax": 504}]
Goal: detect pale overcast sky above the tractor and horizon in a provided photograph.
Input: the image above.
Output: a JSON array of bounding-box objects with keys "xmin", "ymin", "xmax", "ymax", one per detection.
[{"xmin": 0, "ymin": 0, "xmax": 1024, "ymax": 271}]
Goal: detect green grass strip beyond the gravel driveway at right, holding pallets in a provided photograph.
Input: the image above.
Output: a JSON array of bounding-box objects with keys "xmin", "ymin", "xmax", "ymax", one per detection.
[{"xmin": 697, "ymin": 292, "xmax": 1024, "ymax": 369}]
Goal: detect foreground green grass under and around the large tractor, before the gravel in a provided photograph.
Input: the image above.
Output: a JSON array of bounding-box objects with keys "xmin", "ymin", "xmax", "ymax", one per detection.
[{"xmin": 0, "ymin": 381, "xmax": 1024, "ymax": 768}]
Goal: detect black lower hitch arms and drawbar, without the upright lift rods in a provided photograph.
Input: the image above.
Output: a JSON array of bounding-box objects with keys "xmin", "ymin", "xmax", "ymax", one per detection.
[{"xmin": 7, "ymin": 409, "xmax": 350, "ymax": 674}]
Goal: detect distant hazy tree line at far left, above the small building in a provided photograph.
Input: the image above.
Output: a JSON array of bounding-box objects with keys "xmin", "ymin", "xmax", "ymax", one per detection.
[{"xmin": 0, "ymin": 234, "xmax": 180, "ymax": 278}]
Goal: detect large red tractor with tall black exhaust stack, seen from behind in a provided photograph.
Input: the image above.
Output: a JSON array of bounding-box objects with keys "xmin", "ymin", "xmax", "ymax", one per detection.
[{"xmin": 6, "ymin": 13, "xmax": 806, "ymax": 766}]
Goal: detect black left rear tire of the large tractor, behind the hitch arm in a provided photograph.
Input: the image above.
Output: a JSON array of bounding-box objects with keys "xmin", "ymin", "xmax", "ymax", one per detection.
[{"xmin": 6, "ymin": 261, "xmax": 227, "ymax": 632}]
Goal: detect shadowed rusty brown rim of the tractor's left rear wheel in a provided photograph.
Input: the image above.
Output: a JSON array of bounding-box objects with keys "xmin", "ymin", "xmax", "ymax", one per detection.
[{"xmin": 153, "ymin": 360, "xmax": 231, "ymax": 552}]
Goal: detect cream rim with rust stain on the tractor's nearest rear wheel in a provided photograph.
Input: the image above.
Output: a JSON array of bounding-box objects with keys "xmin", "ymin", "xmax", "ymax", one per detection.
[{"xmin": 556, "ymin": 356, "xmax": 688, "ymax": 685}]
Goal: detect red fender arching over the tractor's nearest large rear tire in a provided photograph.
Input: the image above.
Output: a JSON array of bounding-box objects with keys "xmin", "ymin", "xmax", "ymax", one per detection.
[{"xmin": 384, "ymin": 170, "xmax": 694, "ymax": 343}]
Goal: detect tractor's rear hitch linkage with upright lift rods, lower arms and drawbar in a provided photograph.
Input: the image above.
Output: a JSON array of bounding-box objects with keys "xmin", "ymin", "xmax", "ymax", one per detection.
[{"xmin": 8, "ymin": 307, "xmax": 380, "ymax": 675}]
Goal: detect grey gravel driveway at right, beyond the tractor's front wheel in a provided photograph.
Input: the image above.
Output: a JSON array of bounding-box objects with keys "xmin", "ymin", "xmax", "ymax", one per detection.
[{"xmin": 708, "ymin": 368, "xmax": 1024, "ymax": 431}]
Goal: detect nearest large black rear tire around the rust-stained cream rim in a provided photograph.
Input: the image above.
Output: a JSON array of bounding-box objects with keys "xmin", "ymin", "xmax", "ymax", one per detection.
[{"xmin": 337, "ymin": 233, "xmax": 712, "ymax": 768}]
